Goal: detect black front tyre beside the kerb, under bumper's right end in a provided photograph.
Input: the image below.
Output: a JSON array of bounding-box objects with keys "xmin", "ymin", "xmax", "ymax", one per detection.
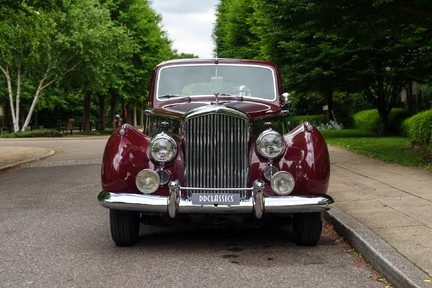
[{"xmin": 292, "ymin": 212, "xmax": 322, "ymax": 246}]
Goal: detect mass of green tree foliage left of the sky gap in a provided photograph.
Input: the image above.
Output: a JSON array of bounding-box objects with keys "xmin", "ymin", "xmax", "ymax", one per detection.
[{"xmin": 0, "ymin": 0, "xmax": 174, "ymax": 129}]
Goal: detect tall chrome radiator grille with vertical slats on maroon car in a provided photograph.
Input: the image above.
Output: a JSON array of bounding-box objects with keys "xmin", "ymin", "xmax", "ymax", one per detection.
[{"xmin": 183, "ymin": 105, "xmax": 251, "ymax": 199}]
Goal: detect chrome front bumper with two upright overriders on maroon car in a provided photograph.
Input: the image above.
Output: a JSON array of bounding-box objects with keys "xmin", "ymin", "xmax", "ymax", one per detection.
[{"xmin": 98, "ymin": 181, "xmax": 334, "ymax": 219}]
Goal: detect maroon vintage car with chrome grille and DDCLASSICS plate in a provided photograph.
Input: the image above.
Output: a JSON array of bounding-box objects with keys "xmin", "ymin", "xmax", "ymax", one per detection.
[{"xmin": 98, "ymin": 59, "xmax": 333, "ymax": 246}]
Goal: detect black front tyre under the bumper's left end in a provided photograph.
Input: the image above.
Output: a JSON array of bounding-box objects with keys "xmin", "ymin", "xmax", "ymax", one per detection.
[{"xmin": 110, "ymin": 209, "xmax": 140, "ymax": 246}]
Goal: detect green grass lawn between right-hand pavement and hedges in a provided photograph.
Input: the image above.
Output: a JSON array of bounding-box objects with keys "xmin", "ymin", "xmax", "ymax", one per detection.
[{"xmin": 321, "ymin": 129, "xmax": 432, "ymax": 168}]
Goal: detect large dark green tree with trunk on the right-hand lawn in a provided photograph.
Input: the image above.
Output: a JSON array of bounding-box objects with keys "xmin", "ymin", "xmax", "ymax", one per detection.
[{"xmin": 253, "ymin": 0, "xmax": 431, "ymax": 134}]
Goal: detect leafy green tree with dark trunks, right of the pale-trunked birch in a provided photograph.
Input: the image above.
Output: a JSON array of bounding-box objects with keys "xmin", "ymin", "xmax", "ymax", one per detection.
[{"xmin": 57, "ymin": 0, "xmax": 138, "ymax": 131}]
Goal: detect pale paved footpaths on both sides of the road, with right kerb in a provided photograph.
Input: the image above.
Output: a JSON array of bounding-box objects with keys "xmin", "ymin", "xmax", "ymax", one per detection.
[{"xmin": 0, "ymin": 146, "xmax": 432, "ymax": 288}]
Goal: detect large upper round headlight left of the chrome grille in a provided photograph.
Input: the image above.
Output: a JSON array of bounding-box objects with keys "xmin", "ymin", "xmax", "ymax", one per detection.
[{"xmin": 150, "ymin": 133, "xmax": 177, "ymax": 163}]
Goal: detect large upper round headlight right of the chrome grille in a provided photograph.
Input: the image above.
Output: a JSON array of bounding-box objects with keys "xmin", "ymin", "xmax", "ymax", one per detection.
[{"xmin": 256, "ymin": 129, "xmax": 285, "ymax": 160}]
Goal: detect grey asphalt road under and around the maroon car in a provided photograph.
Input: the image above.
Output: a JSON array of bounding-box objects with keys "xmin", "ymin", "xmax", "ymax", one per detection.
[{"xmin": 0, "ymin": 138, "xmax": 385, "ymax": 287}]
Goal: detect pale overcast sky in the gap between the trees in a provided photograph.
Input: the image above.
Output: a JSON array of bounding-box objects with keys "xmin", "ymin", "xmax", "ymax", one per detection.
[{"xmin": 152, "ymin": 0, "xmax": 219, "ymax": 58}]
